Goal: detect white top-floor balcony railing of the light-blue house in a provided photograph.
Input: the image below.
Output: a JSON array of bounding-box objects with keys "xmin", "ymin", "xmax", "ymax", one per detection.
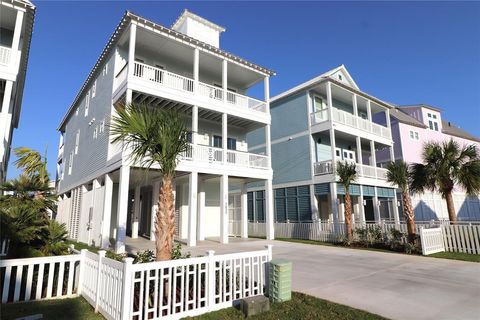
[{"xmin": 310, "ymin": 108, "xmax": 392, "ymax": 139}]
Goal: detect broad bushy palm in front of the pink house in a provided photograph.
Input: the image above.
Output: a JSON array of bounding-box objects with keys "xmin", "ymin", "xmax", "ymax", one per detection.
[{"xmin": 410, "ymin": 139, "xmax": 480, "ymax": 223}]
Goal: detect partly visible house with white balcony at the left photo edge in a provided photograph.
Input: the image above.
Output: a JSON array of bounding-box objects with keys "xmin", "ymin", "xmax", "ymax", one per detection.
[{"xmin": 0, "ymin": 0, "xmax": 35, "ymax": 183}]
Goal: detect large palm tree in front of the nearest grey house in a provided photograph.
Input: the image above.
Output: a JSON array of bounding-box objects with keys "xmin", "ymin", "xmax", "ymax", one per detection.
[{"xmin": 111, "ymin": 103, "xmax": 188, "ymax": 261}]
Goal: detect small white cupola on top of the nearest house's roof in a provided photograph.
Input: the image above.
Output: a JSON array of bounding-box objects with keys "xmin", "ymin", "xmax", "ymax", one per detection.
[{"xmin": 172, "ymin": 9, "xmax": 225, "ymax": 48}]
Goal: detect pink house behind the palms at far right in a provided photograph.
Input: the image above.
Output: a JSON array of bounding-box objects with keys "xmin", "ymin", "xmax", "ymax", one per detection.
[{"xmin": 377, "ymin": 104, "xmax": 480, "ymax": 221}]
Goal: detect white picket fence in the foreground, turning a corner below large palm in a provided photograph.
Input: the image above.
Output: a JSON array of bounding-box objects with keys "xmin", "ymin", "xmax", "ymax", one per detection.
[{"xmin": 0, "ymin": 245, "xmax": 272, "ymax": 320}]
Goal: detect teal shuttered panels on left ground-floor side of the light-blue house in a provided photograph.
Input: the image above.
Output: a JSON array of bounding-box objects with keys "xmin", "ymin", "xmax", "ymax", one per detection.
[{"xmin": 275, "ymin": 185, "xmax": 312, "ymax": 222}]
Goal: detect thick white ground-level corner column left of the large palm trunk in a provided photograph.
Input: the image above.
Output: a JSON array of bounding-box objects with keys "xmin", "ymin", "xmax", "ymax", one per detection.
[{"xmin": 115, "ymin": 165, "xmax": 130, "ymax": 253}]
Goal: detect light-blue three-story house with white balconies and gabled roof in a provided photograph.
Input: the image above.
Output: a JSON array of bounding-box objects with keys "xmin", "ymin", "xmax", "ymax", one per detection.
[{"xmin": 248, "ymin": 65, "xmax": 399, "ymax": 223}]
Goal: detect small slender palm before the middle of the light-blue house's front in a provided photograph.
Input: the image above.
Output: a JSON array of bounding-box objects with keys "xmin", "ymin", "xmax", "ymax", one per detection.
[{"xmin": 336, "ymin": 161, "xmax": 357, "ymax": 241}]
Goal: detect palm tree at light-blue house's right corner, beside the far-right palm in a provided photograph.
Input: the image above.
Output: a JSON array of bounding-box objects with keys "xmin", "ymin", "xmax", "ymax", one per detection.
[{"xmin": 387, "ymin": 160, "xmax": 416, "ymax": 243}]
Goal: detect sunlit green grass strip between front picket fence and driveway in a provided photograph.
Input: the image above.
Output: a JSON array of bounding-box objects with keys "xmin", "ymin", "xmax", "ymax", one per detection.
[{"xmin": 184, "ymin": 292, "xmax": 386, "ymax": 320}]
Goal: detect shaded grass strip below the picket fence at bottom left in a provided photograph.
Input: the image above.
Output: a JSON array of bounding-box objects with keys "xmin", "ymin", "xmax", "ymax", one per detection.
[{"xmin": 0, "ymin": 298, "xmax": 104, "ymax": 320}]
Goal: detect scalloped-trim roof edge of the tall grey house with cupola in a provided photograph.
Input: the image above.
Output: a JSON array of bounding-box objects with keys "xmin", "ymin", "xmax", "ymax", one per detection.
[{"xmin": 57, "ymin": 10, "xmax": 276, "ymax": 130}]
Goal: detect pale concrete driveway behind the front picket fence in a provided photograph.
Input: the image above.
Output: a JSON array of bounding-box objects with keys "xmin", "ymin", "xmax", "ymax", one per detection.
[{"xmin": 126, "ymin": 239, "xmax": 480, "ymax": 320}]
